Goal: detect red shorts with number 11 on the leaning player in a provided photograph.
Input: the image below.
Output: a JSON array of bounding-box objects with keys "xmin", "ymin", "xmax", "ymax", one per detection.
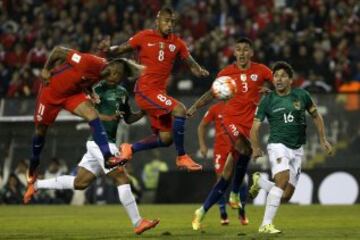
[{"xmin": 34, "ymin": 86, "xmax": 88, "ymax": 125}]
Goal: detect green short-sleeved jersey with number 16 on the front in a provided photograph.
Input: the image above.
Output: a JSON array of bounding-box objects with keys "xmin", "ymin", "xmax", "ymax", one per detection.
[{"xmin": 255, "ymin": 89, "xmax": 314, "ymax": 149}]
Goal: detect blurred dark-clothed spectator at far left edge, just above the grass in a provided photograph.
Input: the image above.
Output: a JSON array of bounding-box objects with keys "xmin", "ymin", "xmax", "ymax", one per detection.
[{"xmin": 0, "ymin": 173, "xmax": 25, "ymax": 204}]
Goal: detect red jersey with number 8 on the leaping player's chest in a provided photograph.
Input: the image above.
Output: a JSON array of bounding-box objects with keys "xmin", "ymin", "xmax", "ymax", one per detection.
[{"xmin": 128, "ymin": 30, "xmax": 190, "ymax": 90}]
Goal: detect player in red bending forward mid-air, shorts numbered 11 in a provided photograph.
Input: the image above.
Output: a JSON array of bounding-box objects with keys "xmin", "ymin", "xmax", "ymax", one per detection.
[{"xmin": 28, "ymin": 47, "xmax": 139, "ymax": 191}]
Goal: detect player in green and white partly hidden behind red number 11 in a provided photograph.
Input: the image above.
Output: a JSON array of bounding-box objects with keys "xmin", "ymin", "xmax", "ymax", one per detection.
[{"xmin": 24, "ymin": 59, "xmax": 159, "ymax": 234}]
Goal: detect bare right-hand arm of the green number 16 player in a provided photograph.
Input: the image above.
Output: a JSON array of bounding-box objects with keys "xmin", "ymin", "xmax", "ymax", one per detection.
[{"xmin": 307, "ymin": 104, "xmax": 333, "ymax": 155}]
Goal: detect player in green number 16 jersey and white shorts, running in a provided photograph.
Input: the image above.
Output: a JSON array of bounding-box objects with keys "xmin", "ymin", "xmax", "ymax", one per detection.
[{"xmin": 249, "ymin": 62, "xmax": 332, "ymax": 233}]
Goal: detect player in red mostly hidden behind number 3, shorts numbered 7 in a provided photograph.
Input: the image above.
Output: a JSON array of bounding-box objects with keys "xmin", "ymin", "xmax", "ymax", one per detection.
[{"xmin": 198, "ymin": 101, "xmax": 249, "ymax": 225}]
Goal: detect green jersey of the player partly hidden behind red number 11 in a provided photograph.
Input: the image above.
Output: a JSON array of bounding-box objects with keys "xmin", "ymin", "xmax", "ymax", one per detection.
[{"xmin": 89, "ymin": 80, "xmax": 131, "ymax": 143}]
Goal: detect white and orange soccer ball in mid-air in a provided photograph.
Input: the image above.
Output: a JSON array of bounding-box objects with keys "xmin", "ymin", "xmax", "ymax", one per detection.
[{"xmin": 211, "ymin": 76, "xmax": 236, "ymax": 100}]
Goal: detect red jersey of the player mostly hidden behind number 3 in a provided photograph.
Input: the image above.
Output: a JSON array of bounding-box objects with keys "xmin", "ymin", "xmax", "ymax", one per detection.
[{"xmin": 203, "ymin": 101, "xmax": 231, "ymax": 149}]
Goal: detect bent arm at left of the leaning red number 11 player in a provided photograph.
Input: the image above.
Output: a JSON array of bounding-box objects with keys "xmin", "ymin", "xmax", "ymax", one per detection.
[{"xmin": 41, "ymin": 46, "xmax": 71, "ymax": 84}]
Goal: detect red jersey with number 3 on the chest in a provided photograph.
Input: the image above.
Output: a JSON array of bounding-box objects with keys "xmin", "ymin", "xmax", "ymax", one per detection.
[{"xmin": 217, "ymin": 62, "xmax": 272, "ymax": 128}]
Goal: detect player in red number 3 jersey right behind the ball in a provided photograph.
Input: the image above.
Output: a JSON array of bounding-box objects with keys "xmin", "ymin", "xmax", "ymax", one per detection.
[{"xmin": 187, "ymin": 38, "xmax": 272, "ymax": 230}]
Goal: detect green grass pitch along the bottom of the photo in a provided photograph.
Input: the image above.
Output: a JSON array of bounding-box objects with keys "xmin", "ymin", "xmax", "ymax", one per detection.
[{"xmin": 0, "ymin": 204, "xmax": 360, "ymax": 240}]
